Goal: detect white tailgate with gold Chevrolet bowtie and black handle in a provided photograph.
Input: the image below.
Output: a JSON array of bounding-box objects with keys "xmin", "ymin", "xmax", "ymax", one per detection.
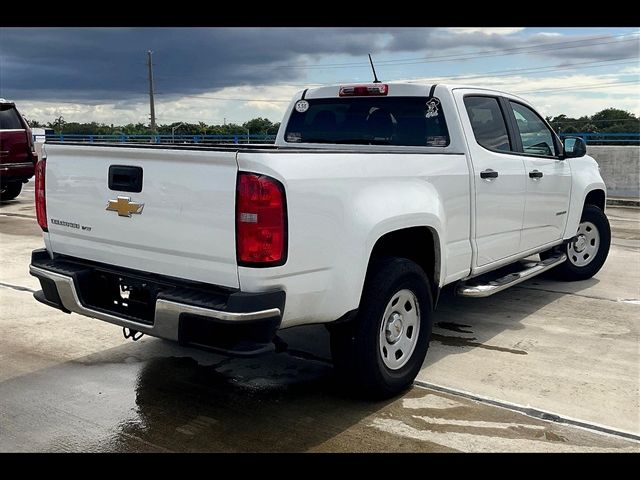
[{"xmin": 46, "ymin": 144, "xmax": 239, "ymax": 288}]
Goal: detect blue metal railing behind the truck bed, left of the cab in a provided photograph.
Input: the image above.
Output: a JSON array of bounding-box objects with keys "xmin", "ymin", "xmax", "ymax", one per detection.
[{"xmin": 46, "ymin": 133, "xmax": 276, "ymax": 144}]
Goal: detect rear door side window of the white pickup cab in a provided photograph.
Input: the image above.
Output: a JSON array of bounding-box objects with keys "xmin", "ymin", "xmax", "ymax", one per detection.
[{"xmin": 464, "ymin": 96, "xmax": 511, "ymax": 152}]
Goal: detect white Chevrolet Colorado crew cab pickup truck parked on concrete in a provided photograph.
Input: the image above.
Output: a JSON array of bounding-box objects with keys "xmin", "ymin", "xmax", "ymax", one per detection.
[{"xmin": 30, "ymin": 83, "xmax": 611, "ymax": 396}]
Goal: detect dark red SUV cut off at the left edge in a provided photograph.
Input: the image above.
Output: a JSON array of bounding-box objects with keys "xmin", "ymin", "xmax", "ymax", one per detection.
[{"xmin": 0, "ymin": 98, "xmax": 38, "ymax": 200}]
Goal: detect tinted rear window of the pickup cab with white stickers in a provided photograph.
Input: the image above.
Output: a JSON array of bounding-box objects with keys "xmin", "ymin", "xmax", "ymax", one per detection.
[{"xmin": 284, "ymin": 97, "xmax": 449, "ymax": 147}]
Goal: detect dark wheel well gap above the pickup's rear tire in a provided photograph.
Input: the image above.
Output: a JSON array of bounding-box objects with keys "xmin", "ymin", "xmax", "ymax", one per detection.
[{"xmin": 367, "ymin": 227, "xmax": 440, "ymax": 294}]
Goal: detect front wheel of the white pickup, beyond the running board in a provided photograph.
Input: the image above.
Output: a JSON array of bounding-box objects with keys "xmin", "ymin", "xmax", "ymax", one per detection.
[{"xmin": 540, "ymin": 205, "xmax": 611, "ymax": 282}]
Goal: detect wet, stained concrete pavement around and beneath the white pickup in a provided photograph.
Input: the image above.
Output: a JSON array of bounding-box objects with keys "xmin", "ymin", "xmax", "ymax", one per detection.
[{"xmin": 0, "ymin": 184, "xmax": 640, "ymax": 452}]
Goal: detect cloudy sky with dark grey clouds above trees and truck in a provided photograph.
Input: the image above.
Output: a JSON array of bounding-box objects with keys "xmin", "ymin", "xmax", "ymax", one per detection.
[{"xmin": 0, "ymin": 27, "xmax": 640, "ymax": 124}]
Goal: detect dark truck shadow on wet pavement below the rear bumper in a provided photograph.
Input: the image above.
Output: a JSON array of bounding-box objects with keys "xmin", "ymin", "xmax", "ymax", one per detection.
[{"xmin": 118, "ymin": 354, "xmax": 390, "ymax": 452}]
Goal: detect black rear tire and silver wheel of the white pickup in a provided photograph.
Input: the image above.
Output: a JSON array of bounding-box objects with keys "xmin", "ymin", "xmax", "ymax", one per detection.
[{"xmin": 330, "ymin": 258, "xmax": 433, "ymax": 398}]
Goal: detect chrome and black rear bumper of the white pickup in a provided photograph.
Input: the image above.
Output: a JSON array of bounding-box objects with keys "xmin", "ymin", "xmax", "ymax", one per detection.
[{"xmin": 29, "ymin": 249, "xmax": 285, "ymax": 355}]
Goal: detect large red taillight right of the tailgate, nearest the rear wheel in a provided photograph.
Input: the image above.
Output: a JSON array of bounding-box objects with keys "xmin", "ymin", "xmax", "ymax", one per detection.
[{"xmin": 236, "ymin": 172, "xmax": 287, "ymax": 267}]
